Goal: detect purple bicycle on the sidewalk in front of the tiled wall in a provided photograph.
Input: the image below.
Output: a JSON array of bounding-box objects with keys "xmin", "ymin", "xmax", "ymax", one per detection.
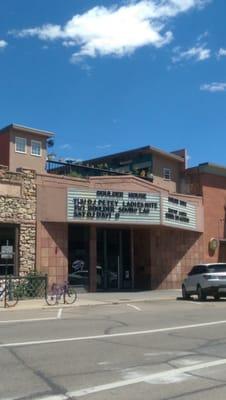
[{"xmin": 45, "ymin": 282, "xmax": 78, "ymax": 306}]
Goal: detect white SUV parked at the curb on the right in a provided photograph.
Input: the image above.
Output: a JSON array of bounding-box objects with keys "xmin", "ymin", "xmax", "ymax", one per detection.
[{"xmin": 182, "ymin": 263, "xmax": 226, "ymax": 300}]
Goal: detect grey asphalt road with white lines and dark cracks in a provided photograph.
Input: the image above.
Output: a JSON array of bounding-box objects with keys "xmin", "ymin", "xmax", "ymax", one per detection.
[{"xmin": 0, "ymin": 300, "xmax": 226, "ymax": 400}]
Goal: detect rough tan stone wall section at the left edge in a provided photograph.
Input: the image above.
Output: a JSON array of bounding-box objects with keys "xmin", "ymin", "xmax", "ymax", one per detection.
[{"xmin": 0, "ymin": 166, "xmax": 36, "ymax": 275}]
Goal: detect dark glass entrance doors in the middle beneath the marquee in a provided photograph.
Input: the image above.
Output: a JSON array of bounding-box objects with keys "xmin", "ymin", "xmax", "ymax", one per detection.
[{"xmin": 97, "ymin": 229, "xmax": 132, "ymax": 290}]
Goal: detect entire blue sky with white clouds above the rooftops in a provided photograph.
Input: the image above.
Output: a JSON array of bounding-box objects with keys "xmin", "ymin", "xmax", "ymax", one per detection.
[{"xmin": 0, "ymin": 0, "xmax": 226, "ymax": 166}]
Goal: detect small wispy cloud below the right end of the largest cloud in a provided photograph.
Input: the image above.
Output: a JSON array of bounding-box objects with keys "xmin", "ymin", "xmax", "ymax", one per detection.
[{"xmin": 172, "ymin": 45, "xmax": 211, "ymax": 63}]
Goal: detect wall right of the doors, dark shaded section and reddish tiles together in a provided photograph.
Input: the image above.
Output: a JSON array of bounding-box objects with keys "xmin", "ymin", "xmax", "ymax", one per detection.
[{"xmin": 134, "ymin": 228, "xmax": 204, "ymax": 289}]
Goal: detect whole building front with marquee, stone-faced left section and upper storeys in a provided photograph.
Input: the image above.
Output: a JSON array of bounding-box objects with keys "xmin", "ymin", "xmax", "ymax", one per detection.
[{"xmin": 0, "ymin": 125, "xmax": 226, "ymax": 291}]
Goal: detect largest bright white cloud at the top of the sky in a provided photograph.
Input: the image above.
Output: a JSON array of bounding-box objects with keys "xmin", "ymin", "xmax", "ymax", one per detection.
[{"xmin": 11, "ymin": 0, "xmax": 209, "ymax": 62}]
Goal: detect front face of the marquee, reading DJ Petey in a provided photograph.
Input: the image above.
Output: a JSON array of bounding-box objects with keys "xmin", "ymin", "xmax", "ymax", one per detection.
[{"xmin": 68, "ymin": 189, "xmax": 160, "ymax": 225}]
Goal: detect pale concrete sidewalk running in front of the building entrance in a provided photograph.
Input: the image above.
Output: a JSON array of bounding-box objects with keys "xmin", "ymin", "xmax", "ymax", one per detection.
[{"xmin": 0, "ymin": 289, "xmax": 181, "ymax": 311}]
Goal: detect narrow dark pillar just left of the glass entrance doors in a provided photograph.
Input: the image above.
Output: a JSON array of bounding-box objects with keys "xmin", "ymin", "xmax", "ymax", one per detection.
[{"xmin": 89, "ymin": 226, "xmax": 97, "ymax": 292}]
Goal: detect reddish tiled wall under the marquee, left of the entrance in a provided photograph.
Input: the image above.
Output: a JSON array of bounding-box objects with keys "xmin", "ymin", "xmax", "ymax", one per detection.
[{"xmin": 38, "ymin": 223, "xmax": 68, "ymax": 285}]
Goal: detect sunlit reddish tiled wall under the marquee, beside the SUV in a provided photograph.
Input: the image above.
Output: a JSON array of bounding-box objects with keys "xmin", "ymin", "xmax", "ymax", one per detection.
[{"xmin": 151, "ymin": 229, "xmax": 203, "ymax": 289}]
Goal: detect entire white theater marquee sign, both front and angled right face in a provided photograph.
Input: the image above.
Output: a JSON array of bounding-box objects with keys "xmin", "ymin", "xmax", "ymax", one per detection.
[{"xmin": 68, "ymin": 189, "xmax": 196, "ymax": 230}]
